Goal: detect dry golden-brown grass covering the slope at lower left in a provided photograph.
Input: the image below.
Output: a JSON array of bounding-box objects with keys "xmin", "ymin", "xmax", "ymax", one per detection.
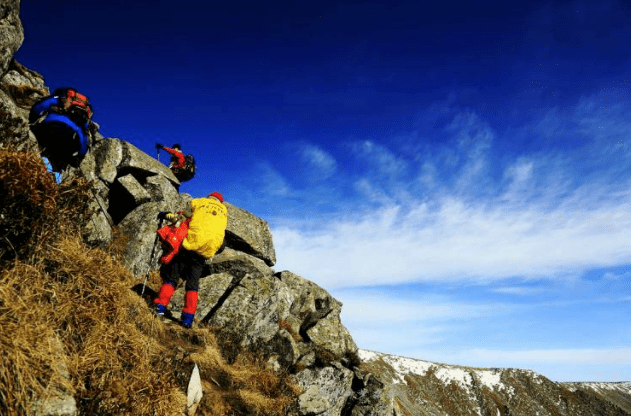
[{"xmin": 0, "ymin": 151, "xmax": 298, "ymax": 416}]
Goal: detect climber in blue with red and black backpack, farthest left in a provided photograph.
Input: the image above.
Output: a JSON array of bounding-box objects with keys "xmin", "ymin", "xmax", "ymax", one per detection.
[{"xmin": 29, "ymin": 88, "xmax": 98, "ymax": 172}]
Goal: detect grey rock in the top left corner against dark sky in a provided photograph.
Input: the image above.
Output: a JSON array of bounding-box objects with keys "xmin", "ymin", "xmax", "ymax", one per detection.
[{"xmin": 0, "ymin": 0, "xmax": 24, "ymax": 77}]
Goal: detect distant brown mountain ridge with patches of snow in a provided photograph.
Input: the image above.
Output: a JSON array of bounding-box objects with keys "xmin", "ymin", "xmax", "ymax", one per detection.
[{"xmin": 359, "ymin": 350, "xmax": 631, "ymax": 416}]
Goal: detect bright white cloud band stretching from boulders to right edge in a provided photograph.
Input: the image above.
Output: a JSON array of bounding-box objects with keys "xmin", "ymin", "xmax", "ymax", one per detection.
[{"xmin": 273, "ymin": 184, "xmax": 631, "ymax": 287}]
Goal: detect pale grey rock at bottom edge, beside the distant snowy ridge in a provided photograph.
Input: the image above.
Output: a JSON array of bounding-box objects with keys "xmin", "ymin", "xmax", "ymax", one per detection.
[{"xmin": 293, "ymin": 366, "xmax": 353, "ymax": 416}]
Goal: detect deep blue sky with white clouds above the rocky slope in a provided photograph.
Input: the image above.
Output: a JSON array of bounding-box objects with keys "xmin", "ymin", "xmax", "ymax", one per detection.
[{"xmin": 16, "ymin": 0, "xmax": 631, "ymax": 381}]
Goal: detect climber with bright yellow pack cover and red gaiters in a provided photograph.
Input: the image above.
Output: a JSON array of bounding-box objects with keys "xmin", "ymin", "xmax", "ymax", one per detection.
[{"xmin": 153, "ymin": 192, "xmax": 228, "ymax": 328}]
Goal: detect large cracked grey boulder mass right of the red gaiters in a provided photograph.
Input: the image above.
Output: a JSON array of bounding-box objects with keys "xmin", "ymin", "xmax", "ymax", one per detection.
[{"xmin": 171, "ymin": 254, "xmax": 357, "ymax": 370}]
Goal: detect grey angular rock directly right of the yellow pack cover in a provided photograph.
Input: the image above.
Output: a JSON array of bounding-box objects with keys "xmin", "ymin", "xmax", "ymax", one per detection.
[{"xmin": 225, "ymin": 202, "xmax": 276, "ymax": 266}]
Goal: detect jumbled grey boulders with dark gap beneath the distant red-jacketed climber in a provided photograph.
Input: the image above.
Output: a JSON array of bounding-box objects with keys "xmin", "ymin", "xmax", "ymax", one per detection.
[{"xmin": 80, "ymin": 135, "xmax": 186, "ymax": 252}]
